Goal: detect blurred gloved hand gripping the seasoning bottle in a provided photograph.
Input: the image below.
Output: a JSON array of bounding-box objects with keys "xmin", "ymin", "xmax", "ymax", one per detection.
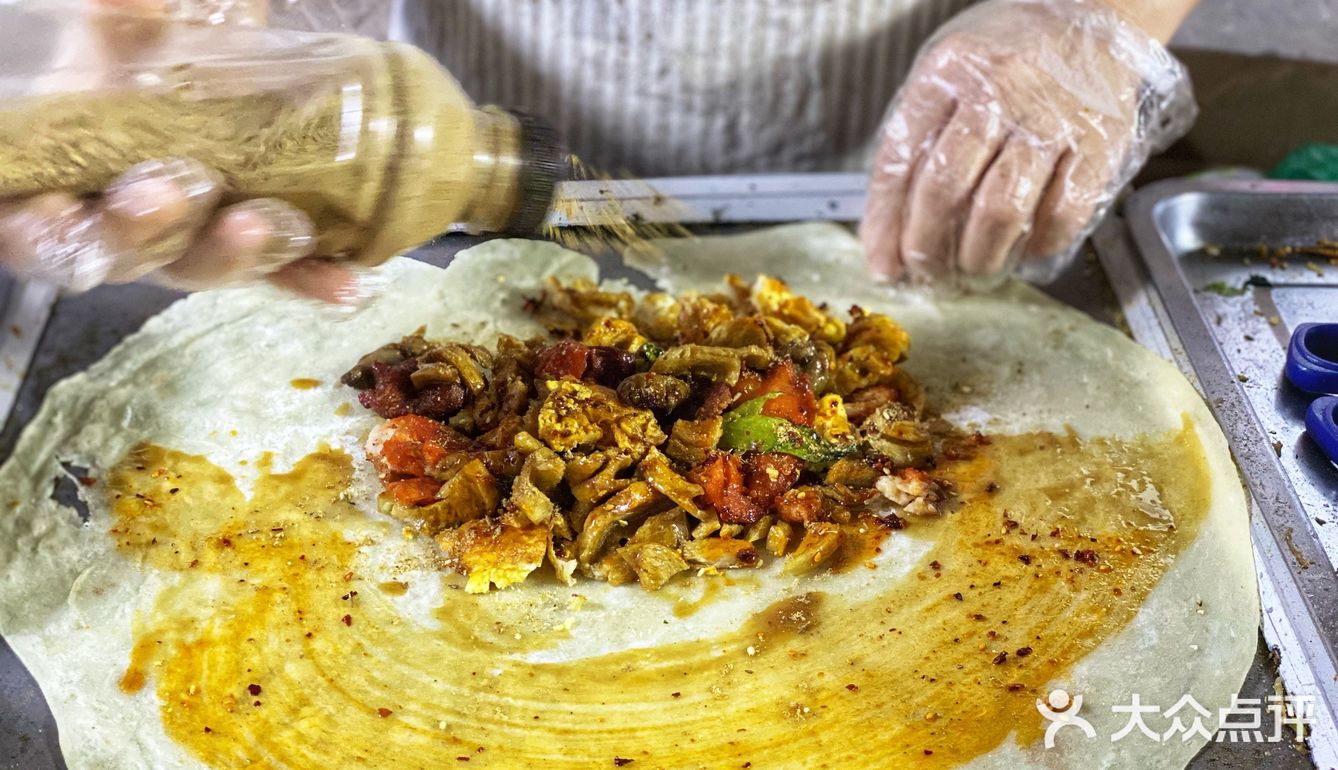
[{"xmin": 0, "ymin": 0, "xmax": 367, "ymax": 303}]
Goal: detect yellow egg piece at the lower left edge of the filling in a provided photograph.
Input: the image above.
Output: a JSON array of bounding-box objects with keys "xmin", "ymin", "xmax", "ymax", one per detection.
[{"xmin": 436, "ymin": 518, "xmax": 549, "ymax": 593}]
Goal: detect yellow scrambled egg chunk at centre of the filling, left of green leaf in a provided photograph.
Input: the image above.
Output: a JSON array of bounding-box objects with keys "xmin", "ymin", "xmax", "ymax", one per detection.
[{"xmin": 538, "ymin": 380, "xmax": 666, "ymax": 454}]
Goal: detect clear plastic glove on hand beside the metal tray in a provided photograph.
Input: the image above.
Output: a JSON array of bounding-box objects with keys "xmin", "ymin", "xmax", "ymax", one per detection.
[{"xmin": 860, "ymin": 0, "xmax": 1196, "ymax": 285}]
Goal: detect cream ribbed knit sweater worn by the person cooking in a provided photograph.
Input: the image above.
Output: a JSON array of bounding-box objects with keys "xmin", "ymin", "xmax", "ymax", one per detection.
[{"xmin": 276, "ymin": 0, "xmax": 970, "ymax": 175}]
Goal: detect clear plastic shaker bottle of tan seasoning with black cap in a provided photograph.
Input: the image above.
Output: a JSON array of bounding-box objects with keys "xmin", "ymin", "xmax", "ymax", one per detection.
[{"xmin": 0, "ymin": 0, "xmax": 566, "ymax": 265}]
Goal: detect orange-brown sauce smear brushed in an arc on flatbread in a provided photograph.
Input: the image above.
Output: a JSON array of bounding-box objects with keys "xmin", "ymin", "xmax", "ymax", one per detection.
[{"xmin": 108, "ymin": 420, "xmax": 1211, "ymax": 767}]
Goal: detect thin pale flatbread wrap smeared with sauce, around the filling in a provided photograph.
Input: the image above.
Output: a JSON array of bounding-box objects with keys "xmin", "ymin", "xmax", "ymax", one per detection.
[{"xmin": 0, "ymin": 225, "xmax": 1258, "ymax": 769}]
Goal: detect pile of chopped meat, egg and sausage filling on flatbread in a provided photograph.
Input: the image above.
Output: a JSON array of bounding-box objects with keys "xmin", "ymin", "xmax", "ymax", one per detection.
[{"xmin": 343, "ymin": 276, "xmax": 973, "ymax": 592}]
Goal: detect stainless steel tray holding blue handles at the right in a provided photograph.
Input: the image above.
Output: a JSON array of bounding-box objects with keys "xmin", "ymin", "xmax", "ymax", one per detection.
[{"xmin": 1096, "ymin": 179, "xmax": 1338, "ymax": 767}]
